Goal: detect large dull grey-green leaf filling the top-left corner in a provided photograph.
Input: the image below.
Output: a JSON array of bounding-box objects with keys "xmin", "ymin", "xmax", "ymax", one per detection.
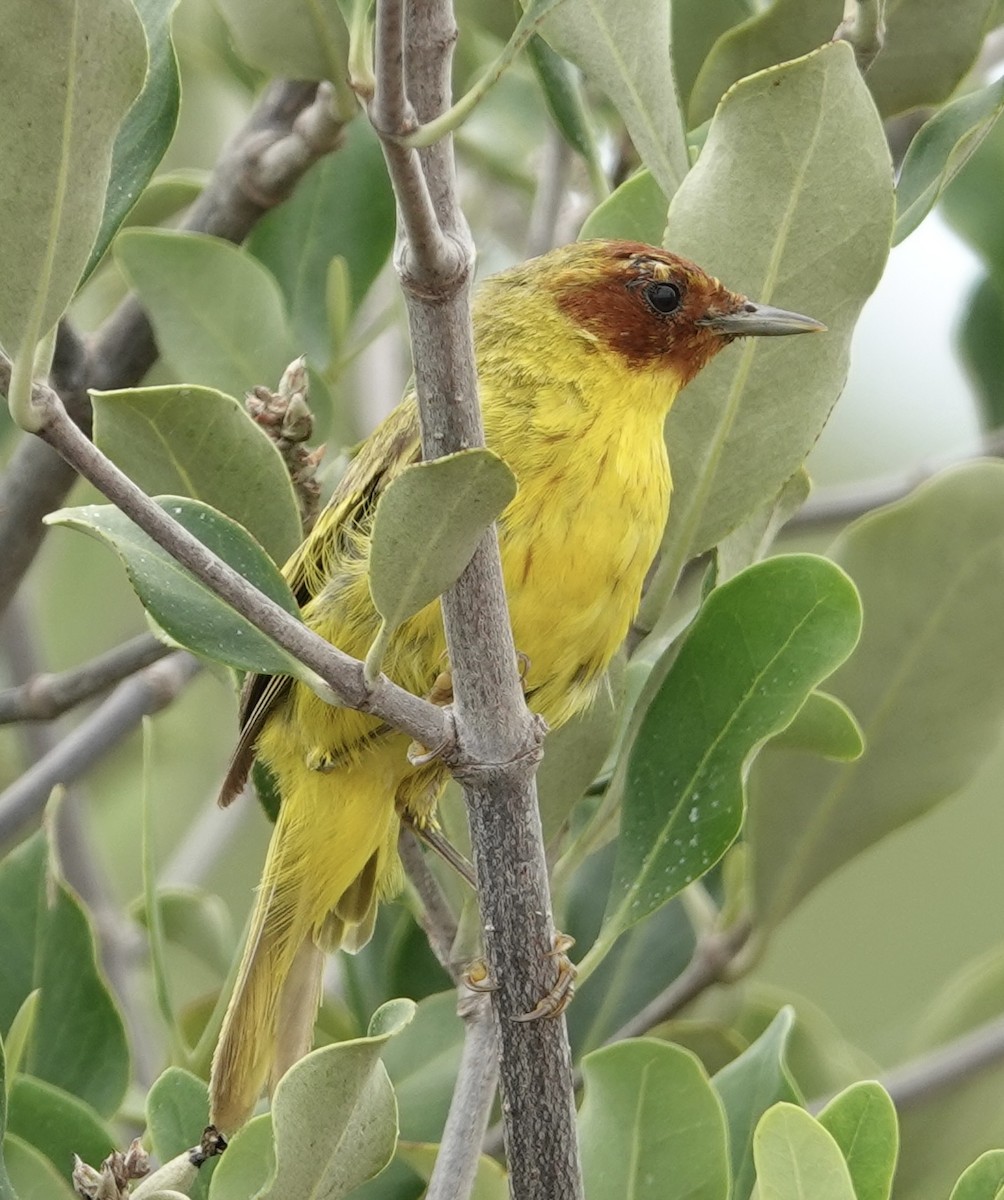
[{"xmin": 0, "ymin": 0, "xmax": 146, "ymax": 358}]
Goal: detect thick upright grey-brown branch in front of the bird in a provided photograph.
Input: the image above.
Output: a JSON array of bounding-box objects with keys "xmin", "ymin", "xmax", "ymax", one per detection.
[{"xmin": 371, "ymin": 0, "xmax": 582, "ymax": 1200}]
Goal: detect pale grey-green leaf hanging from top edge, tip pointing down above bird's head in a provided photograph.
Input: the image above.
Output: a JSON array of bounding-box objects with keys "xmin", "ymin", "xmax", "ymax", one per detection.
[{"xmin": 524, "ymin": 0, "xmax": 687, "ymax": 196}]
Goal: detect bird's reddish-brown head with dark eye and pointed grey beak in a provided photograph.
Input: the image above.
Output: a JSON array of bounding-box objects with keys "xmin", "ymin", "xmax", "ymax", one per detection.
[{"xmin": 549, "ymin": 241, "xmax": 826, "ymax": 384}]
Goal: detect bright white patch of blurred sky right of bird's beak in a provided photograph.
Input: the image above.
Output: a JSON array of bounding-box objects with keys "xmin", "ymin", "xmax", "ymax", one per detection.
[{"xmin": 807, "ymin": 212, "xmax": 981, "ymax": 487}]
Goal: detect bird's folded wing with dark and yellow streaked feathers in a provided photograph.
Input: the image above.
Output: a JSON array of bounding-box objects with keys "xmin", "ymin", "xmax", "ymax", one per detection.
[{"xmin": 220, "ymin": 396, "xmax": 421, "ymax": 805}]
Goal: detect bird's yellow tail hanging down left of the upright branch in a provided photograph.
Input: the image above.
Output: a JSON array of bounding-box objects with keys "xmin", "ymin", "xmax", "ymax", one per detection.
[{"xmin": 210, "ymin": 758, "xmax": 398, "ymax": 1132}]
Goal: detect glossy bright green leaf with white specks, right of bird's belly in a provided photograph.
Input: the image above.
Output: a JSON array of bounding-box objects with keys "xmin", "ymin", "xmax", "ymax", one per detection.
[{"xmin": 581, "ymin": 554, "xmax": 861, "ymax": 976}]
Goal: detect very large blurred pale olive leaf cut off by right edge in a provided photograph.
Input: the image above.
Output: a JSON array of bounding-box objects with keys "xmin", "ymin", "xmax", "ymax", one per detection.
[{"xmin": 747, "ymin": 462, "xmax": 1004, "ymax": 929}]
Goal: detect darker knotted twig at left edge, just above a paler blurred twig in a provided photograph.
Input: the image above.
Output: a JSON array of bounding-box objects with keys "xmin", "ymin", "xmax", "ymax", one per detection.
[{"xmin": 0, "ymin": 634, "xmax": 170, "ymax": 725}]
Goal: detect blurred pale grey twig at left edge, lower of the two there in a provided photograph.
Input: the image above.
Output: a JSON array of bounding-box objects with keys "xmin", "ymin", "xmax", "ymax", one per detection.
[{"xmin": 0, "ymin": 648, "xmax": 199, "ymax": 842}]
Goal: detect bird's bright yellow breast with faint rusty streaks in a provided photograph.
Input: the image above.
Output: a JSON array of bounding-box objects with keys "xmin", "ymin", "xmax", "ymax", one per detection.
[{"xmin": 500, "ymin": 403, "xmax": 669, "ymax": 726}]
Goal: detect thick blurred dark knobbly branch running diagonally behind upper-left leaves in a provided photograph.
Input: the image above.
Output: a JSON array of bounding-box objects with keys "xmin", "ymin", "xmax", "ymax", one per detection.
[{"xmin": 0, "ymin": 80, "xmax": 342, "ymax": 612}]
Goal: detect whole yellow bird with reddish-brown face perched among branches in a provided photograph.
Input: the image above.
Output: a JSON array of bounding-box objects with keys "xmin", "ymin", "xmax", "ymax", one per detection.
[{"xmin": 211, "ymin": 241, "xmax": 823, "ymax": 1130}]
